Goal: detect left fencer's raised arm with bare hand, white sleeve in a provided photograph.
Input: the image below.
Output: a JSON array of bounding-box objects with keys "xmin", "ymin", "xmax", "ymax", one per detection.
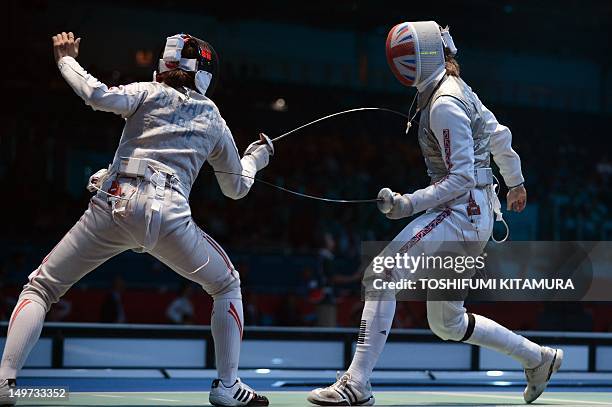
[{"xmin": 52, "ymin": 32, "xmax": 147, "ymax": 117}]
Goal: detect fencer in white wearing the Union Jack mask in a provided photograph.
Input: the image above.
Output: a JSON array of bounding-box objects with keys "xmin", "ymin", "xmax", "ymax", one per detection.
[{"xmin": 308, "ymin": 21, "xmax": 563, "ymax": 405}]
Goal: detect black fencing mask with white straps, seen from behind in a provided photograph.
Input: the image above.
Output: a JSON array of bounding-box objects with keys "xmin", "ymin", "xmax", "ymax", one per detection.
[{"xmin": 153, "ymin": 34, "xmax": 219, "ymax": 96}]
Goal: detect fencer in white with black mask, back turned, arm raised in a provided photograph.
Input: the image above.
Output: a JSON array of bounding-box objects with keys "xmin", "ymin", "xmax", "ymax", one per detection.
[{"xmin": 0, "ymin": 33, "xmax": 273, "ymax": 406}]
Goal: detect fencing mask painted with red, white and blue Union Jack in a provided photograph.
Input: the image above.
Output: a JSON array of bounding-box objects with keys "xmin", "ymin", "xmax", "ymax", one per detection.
[{"xmin": 386, "ymin": 21, "xmax": 457, "ymax": 86}]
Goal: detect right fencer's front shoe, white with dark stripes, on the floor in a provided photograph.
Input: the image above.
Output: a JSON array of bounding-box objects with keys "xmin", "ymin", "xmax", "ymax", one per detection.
[{"xmin": 307, "ymin": 372, "xmax": 374, "ymax": 406}]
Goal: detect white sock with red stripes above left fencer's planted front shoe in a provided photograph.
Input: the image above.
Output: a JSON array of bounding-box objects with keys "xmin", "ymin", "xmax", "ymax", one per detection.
[{"xmin": 211, "ymin": 298, "xmax": 244, "ymax": 387}]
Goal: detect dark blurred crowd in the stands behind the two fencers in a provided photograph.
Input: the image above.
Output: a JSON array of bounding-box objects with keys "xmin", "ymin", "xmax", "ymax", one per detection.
[{"xmin": 0, "ymin": 3, "xmax": 612, "ymax": 331}]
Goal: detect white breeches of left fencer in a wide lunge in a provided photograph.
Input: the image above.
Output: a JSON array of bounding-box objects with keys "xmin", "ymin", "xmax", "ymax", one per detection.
[{"xmin": 20, "ymin": 179, "xmax": 240, "ymax": 310}]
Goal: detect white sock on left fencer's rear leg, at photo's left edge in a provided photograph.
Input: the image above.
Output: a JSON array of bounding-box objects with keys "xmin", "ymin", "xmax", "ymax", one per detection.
[{"xmin": 0, "ymin": 298, "xmax": 47, "ymax": 380}]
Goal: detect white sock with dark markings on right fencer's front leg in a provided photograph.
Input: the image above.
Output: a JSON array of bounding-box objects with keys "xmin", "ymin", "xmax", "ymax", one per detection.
[{"xmin": 348, "ymin": 300, "xmax": 395, "ymax": 385}]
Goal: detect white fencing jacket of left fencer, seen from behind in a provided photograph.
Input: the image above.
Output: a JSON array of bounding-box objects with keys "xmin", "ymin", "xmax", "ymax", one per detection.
[{"xmin": 58, "ymin": 57, "xmax": 260, "ymax": 199}]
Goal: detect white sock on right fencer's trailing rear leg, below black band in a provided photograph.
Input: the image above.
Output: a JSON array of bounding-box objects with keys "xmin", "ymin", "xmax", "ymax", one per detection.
[{"xmin": 465, "ymin": 314, "xmax": 542, "ymax": 369}]
